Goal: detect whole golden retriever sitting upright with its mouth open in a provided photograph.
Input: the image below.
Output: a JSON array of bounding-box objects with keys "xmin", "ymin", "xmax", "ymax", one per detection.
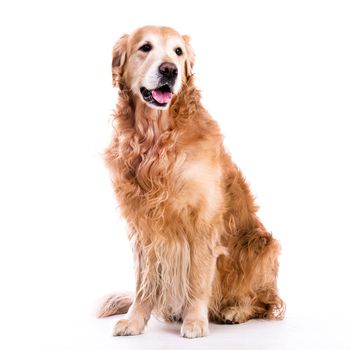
[{"xmin": 98, "ymin": 26, "xmax": 285, "ymax": 338}]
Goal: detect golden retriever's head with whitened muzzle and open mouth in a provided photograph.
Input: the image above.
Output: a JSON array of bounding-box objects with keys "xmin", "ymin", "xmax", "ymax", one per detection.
[{"xmin": 112, "ymin": 26, "xmax": 194, "ymax": 109}]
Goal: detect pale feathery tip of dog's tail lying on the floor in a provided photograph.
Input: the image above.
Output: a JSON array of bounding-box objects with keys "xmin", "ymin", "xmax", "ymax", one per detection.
[{"xmin": 96, "ymin": 293, "xmax": 134, "ymax": 317}]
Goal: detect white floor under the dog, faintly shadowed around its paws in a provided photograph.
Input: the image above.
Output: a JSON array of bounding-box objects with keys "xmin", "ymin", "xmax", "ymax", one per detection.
[{"xmin": 1, "ymin": 308, "xmax": 350, "ymax": 350}]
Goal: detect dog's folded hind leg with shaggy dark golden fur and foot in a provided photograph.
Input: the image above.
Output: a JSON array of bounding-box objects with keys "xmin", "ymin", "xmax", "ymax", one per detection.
[{"xmin": 217, "ymin": 228, "xmax": 285, "ymax": 323}]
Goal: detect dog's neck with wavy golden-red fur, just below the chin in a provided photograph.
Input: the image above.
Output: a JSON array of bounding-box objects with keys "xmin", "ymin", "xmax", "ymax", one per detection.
[{"xmin": 114, "ymin": 77, "xmax": 205, "ymax": 182}]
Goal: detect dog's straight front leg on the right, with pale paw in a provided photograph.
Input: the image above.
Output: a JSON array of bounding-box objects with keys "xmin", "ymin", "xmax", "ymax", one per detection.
[{"xmin": 181, "ymin": 241, "xmax": 216, "ymax": 338}]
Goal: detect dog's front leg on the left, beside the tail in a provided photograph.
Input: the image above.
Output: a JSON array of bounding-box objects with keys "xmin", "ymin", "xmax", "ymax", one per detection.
[{"xmin": 113, "ymin": 250, "xmax": 153, "ymax": 336}]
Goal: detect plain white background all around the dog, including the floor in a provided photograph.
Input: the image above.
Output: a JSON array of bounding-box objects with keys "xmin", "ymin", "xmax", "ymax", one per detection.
[{"xmin": 0, "ymin": 0, "xmax": 350, "ymax": 350}]
